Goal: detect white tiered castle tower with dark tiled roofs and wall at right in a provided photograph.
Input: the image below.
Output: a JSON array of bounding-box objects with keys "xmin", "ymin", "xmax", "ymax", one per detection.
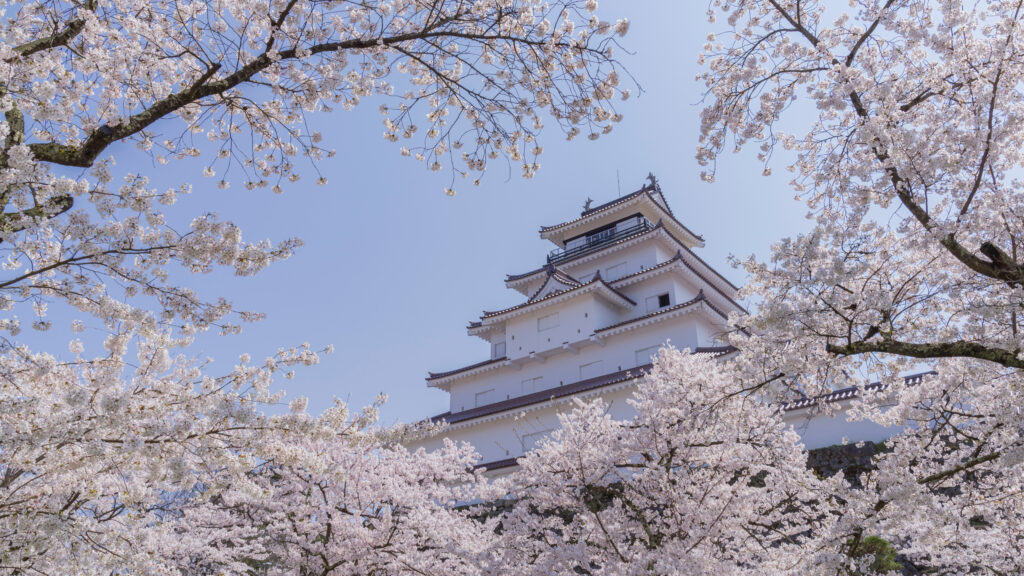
[{"xmin": 412, "ymin": 175, "xmax": 905, "ymax": 470}]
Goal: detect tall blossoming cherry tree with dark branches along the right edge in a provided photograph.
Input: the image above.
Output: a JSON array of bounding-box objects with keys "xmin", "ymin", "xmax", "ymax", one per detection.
[{"xmin": 697, "ymin": 0, "xmax": 1024, "ymax": 574}]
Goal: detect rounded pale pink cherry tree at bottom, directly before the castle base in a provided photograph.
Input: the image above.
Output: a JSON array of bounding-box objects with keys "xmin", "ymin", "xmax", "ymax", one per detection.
[{"xmin": 496, "ymin": 348, "xmax": 847, "ymax": 575}]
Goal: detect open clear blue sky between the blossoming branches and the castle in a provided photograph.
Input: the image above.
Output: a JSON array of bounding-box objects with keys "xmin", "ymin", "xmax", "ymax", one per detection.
[{"xmin": 36, "ymin": 0, "xmax": 808, "ymax": 423}]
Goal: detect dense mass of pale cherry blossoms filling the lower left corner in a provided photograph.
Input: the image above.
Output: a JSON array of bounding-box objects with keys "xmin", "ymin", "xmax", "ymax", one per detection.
[{"xmin": 0, "ymin": 339, "xmax": 494, "ymax": 575}]
